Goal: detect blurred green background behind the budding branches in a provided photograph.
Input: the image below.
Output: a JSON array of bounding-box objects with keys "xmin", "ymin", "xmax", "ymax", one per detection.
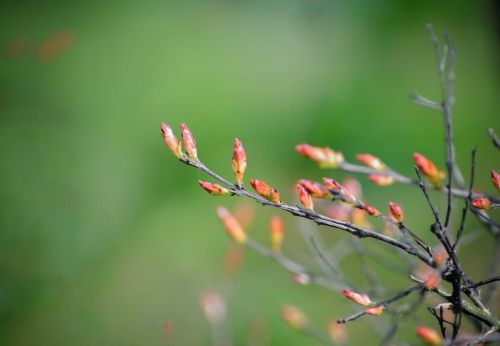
[{"xmin": 0, "ymin": 0, "xmax": 500, "ymax": 346}]
